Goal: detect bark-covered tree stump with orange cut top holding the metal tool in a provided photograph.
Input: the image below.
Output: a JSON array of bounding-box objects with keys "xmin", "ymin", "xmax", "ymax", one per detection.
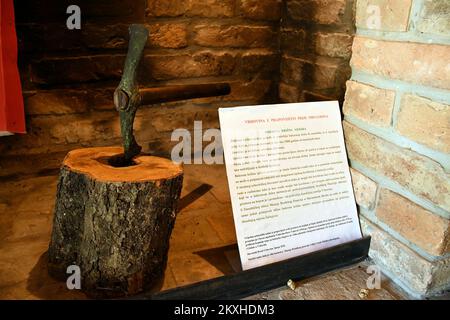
[{"xmin": 48, "ymin": 147, "xmax": 183, "ymax": 297}]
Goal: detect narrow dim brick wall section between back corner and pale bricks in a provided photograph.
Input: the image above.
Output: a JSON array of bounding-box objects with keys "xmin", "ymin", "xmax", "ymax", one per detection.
[{"xmin": 279, "ymin": 0, "xmax": 354, "ymax": 102}]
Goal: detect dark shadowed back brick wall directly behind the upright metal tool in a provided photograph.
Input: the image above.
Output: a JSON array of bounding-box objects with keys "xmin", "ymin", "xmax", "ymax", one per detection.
[{"xmin": 0, "ymin": 0, "xmax": 281, "ymax": 176}]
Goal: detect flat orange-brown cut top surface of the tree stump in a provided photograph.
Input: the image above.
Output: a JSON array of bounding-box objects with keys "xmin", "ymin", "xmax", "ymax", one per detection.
[{"xmin": 63, "ymin": 147, "xmax": 183, "ymax": 182}]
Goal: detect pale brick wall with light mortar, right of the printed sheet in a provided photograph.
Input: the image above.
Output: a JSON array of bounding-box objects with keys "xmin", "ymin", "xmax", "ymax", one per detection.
[{"xmin": 344, "ymin": 0, "xmax": 450, "ymax": 296}]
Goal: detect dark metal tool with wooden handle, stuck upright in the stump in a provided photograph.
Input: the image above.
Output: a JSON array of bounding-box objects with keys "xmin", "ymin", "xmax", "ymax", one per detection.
[{"xmin": 114, "ymin": 24, "xmax": 231, "ymax": 166}]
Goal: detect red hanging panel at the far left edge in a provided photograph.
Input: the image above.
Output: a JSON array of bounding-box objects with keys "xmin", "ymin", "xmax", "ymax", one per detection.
[{"xmin": 0, "ymin": 0, "xmax": 25, "ymax": 135}]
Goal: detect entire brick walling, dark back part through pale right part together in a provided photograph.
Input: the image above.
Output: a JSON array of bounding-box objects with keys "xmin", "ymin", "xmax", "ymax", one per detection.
[{"xmin": 0, "ymin": 0, "xmax": 450, "ymax": 296}]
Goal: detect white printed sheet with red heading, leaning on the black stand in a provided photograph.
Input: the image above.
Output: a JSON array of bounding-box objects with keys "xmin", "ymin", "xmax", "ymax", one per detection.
[{"xmin": 219, "ymin": 101, "xmax": 361, "ymax": 270}]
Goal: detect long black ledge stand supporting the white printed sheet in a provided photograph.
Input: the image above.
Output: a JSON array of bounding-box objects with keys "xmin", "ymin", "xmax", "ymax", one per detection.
[{"xmin": 140, "ymin": 237, "xmax": 370, "ymax": 300}]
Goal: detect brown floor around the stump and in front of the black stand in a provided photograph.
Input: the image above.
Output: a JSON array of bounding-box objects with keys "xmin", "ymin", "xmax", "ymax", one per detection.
[{"xmin": 0, "ymin": 165, "xmax": 405, "ymax": 300}]
